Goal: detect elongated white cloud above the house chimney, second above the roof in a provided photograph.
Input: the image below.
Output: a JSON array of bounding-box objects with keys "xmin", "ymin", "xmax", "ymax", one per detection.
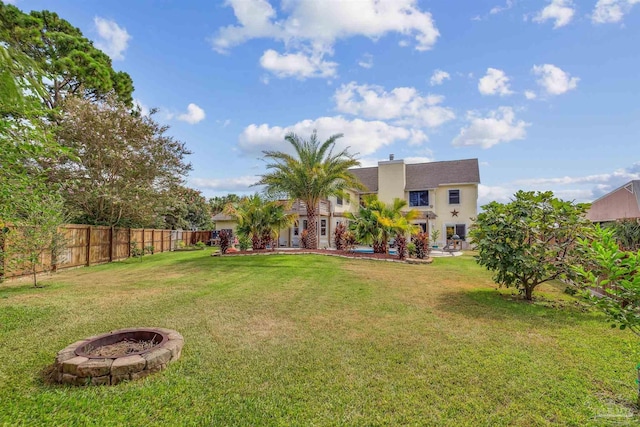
[{"xmin": 334, "ymin": 82, "xmax": 455, "ymax": 127}]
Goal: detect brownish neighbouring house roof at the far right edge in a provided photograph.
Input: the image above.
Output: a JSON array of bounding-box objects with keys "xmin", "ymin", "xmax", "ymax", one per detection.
[{"xmin": 587, "ymin": 180, "xmax": 640, "ymax": 223}]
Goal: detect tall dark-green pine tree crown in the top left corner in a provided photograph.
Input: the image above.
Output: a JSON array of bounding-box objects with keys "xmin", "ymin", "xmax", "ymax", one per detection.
[{"xmin": 0, "ymin": 2, "xmax": 133, "ymax": 109}]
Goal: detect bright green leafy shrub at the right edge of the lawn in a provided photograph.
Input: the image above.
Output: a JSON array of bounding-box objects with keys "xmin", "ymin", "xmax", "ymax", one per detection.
[{"xmin": 573, "ymin": 226, "xmax": 640, "ymax": 336}]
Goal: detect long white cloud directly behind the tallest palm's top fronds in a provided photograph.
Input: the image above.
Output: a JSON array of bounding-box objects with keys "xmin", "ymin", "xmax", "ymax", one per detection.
[{"xmin": 238, "ymin": 116, "xmax": 428, "ymax": 156}]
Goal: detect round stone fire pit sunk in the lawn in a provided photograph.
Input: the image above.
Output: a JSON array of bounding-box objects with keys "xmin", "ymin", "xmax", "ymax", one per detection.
[{"xmin": 55, "ymin": 328, "xmax": 184, "ymax": 385}]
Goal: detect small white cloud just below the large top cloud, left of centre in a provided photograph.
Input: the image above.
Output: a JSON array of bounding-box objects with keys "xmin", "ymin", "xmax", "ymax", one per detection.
[{"xmin": 260, "ymin": 49, "xmax": 338, "ymax": 79}]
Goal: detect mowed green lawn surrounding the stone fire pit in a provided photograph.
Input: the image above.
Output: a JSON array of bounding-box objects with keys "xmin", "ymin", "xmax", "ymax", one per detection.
[{"xmin": 0, "ymin": 251, "xmax": 640, "ymax": 426}]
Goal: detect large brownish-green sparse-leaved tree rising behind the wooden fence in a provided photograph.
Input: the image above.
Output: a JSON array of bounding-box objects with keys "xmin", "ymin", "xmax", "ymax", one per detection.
[{"xmin": 45, "ymin": 97, "xmax": 191, "ymax": 227}]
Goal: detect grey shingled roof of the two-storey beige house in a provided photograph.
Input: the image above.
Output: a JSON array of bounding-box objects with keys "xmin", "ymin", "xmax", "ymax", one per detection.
[{"xmin": 351, "ymin": 159, "xmax": 480, "ymax": 193}]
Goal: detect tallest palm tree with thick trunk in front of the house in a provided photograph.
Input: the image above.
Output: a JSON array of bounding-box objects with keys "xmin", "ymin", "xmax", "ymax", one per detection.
[{"xmin": 257, "ymin": 130, "xmax": 362, "ymax": 249}]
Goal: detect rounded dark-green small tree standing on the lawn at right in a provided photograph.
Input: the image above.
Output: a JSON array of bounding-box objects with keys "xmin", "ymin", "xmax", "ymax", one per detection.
[{"xmin": 469, "ymin": 191, "xmax": 591, "ymax": 300}]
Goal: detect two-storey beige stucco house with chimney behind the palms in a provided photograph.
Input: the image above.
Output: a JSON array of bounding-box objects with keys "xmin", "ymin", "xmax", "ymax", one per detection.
[{"xmin": 213, "ymin": 156, "xmax": 480, "ymax": 248}]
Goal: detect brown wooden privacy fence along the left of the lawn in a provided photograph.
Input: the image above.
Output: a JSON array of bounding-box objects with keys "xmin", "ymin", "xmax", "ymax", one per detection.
[{"xmin": 0, "ymin": 224, "xmax": 211, "ymax": 279}]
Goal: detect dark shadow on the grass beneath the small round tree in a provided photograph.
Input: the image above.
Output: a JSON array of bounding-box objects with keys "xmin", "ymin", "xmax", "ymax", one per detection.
[{"xmin": 436, "ymin": 289, "xmax": 602, "ymax": 328}]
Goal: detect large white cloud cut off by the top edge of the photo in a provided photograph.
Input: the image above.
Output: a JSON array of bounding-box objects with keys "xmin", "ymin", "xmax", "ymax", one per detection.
[{"xmin": 210, "ymin": 0, "xmax": 440, "ymax": 76}]
